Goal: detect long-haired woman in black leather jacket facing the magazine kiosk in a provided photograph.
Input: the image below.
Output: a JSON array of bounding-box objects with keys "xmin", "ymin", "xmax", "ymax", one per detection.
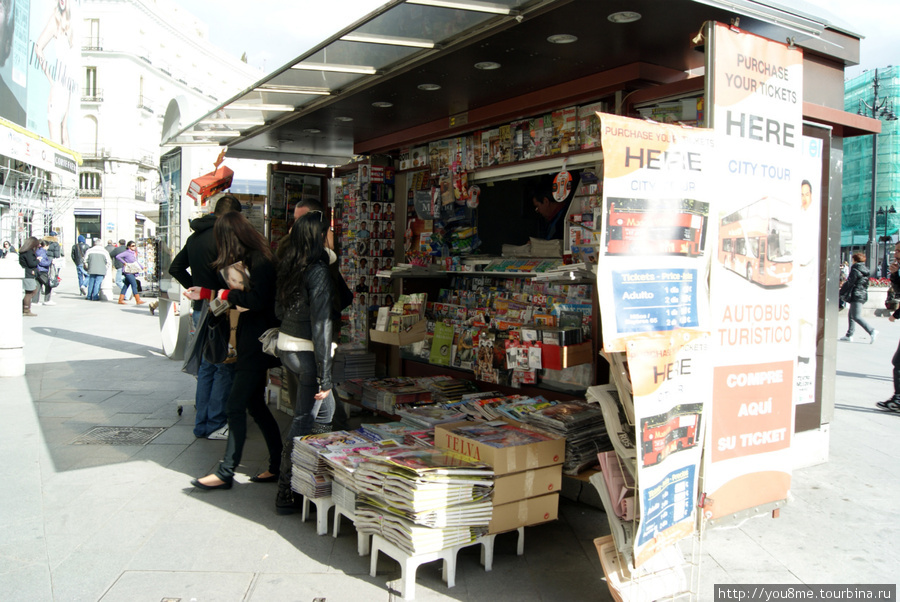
[{"xmin": 275, "ymin": 211, "xmax": 335, "ymax": 514}]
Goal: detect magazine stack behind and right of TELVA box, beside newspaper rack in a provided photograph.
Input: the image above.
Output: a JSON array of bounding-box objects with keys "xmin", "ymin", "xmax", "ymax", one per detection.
[{"xmin": 523, "ymin": 401, "xmax": 612, "ymax": 475}]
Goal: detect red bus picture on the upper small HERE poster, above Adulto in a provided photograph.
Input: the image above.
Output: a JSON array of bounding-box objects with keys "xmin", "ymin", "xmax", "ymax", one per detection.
[{"xmin": 606, "ymin": 197, "xmax": 709, "ymax": 257}]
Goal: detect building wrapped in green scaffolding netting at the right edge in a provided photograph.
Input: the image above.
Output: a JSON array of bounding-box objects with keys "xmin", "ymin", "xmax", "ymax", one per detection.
[{"xmin": 841, "ymin": 66, "xmax": 900, "ymax": 259}]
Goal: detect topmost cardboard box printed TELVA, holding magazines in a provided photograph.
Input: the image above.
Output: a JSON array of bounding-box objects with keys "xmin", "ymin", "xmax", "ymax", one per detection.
[{"xmin": 434, "ymin": 420, "xmax": 566, "ymax": 476}]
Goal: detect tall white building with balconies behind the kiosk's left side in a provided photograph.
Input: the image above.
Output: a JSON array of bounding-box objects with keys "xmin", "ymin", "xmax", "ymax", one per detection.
[{"xmin": 69, "ymin": 0, "xmax": 262, "ymax": 248}]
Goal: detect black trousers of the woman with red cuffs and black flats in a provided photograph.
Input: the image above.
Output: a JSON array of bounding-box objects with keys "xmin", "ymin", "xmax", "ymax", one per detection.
[{"xmin": 216, "ymin": 368, "xmax": 282, "ymax": 482}]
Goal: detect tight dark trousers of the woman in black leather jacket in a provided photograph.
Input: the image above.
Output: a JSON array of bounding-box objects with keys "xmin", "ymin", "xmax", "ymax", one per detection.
[{"xmin": 278, "ymin": 349, "xmax": 335, "ymax": 491}]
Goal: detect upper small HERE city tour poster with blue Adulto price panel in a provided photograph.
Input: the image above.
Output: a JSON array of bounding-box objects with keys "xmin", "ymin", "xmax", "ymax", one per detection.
[{"xmin": 595, "ymin": 113, "xmax": 715, "ymax": 352}]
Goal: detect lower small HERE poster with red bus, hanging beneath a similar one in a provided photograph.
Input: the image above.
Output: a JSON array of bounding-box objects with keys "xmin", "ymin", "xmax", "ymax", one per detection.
[{"xmin": 627, "ymin": 330, "xmax": 711, "ymax": 566}]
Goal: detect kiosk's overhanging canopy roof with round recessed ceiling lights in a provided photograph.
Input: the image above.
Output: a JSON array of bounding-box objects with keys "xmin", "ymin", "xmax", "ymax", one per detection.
[{"xmin": 163, "ymin": 0, "xmax": 869, "ymax": 166}]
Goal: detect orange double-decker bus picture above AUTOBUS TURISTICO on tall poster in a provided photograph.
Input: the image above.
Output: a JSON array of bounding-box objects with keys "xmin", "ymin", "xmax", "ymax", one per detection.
[{"xmin": 718, "ymin": 196, "xmax": 794, "ymax": 286}]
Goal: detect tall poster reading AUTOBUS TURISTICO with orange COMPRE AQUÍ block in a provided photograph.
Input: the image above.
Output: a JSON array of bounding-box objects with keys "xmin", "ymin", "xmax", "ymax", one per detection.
[{"xmin": 704, "ymin": 24, "xmax": 804, "ymax": 519}]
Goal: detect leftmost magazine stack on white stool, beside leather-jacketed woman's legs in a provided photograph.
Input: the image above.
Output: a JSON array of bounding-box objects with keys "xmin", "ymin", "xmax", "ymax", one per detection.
[{"xmin": 291, "ymin": 431, "xmax": 372, "ymax": 498}]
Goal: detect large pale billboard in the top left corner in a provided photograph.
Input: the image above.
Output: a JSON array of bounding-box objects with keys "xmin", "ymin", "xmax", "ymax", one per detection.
[{"xmin": 0, "ymin": 0, "xmax": 81, "ymax": 148}]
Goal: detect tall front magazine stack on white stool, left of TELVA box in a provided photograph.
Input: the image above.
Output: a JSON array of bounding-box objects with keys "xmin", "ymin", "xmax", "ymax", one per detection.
[{"xmin": 353, "ymin": 447, "xmax": 493, "ymax": 555}]
